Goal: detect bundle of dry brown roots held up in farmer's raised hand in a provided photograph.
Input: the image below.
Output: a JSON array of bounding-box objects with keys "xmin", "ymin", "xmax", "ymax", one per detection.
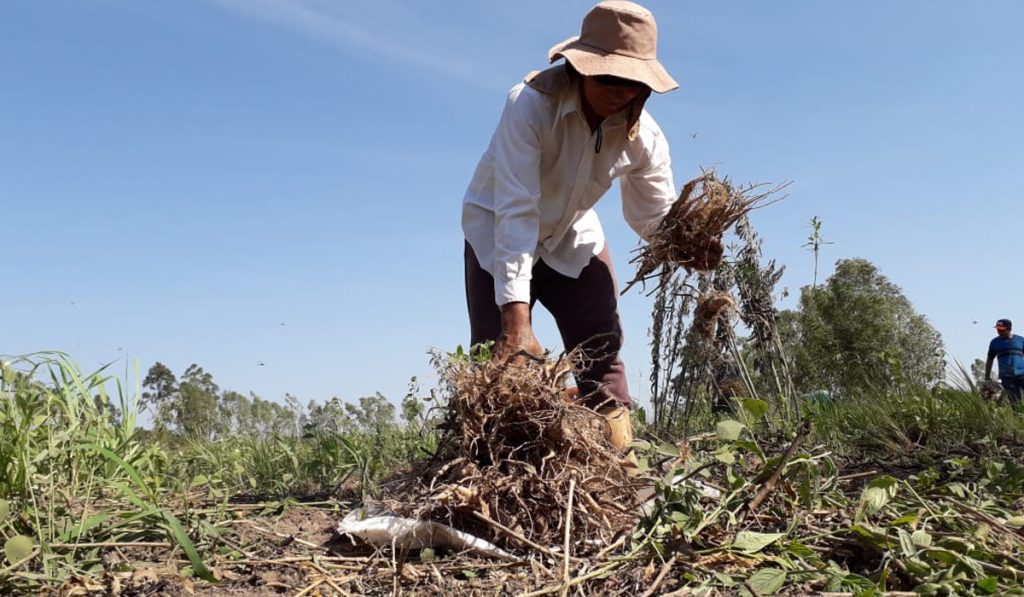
[{"xmin": 623, "ymin": 171, "xmax": 784, "ymax": 294}]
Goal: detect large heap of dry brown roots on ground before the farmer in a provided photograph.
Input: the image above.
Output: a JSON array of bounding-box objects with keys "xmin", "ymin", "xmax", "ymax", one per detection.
[{"xmin": 386, "ymin": 359, "xmax": 637, "ymax": 555}]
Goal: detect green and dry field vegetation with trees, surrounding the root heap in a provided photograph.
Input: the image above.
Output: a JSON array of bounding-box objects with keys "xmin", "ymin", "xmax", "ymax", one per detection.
[{"xmin": 0, "ymin": 218, "xmax": 1024, "ymax": 596}]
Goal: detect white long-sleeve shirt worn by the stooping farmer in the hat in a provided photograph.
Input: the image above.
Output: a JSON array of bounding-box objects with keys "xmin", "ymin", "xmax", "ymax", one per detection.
[{"xmin": 462, "ymin": 71, "xmax": 676, "ymax": 305}]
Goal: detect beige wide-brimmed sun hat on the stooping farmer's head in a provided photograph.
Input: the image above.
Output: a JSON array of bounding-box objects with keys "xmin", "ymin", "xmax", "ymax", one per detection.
[{"xmin": 548, "ymin": 0, "xmax": 679, "ymax": 93}]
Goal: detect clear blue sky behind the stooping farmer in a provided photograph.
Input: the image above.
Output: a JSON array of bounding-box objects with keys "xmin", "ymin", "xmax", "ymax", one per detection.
[{"xmin": 0, "ymin": 0, "xmax": 1024, "ymax": 409}]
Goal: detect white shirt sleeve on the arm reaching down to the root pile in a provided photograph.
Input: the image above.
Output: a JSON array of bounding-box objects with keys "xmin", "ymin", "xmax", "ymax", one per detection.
[{"xmin": 492, "ymin": 86, "xmax": 544, "ymax": 305}]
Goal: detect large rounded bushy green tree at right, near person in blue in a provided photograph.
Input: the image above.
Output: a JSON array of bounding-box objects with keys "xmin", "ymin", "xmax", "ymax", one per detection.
[{"xmin": 779, "ymin": 259, "xmax": 945, "ymax": 395}]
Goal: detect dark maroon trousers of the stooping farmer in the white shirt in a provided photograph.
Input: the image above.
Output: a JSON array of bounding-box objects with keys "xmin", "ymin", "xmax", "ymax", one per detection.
[{"xmin": 465, "ymin": 243, "xmax": 632, "ymax": 408}]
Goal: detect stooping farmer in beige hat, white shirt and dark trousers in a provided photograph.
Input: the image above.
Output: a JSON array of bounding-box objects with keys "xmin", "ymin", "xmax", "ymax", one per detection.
[{"xmin": 462, "ymin": 0, "xmax": 696, "ymax": 449}]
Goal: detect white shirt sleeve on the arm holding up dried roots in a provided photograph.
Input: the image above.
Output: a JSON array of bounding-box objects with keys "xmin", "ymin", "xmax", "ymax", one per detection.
[{"xmin": 621, "ymin": 125, "xmax": 676, "ymax": 241}]
